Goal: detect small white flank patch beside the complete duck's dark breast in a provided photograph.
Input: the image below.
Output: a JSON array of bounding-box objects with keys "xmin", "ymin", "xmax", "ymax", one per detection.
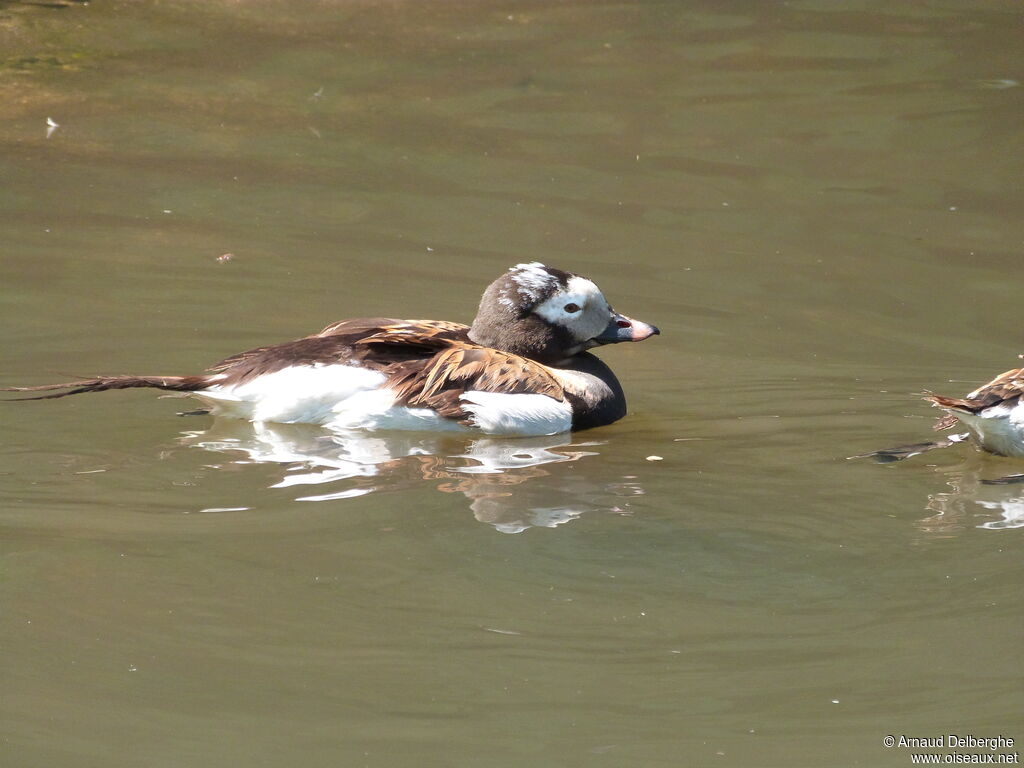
[{"xmin": 460, "ymin": 391, "xmax": 572, "ymax": 435}]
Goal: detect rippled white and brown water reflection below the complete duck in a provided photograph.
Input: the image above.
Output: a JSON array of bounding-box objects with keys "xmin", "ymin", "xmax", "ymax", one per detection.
[{"xmin": 181, "ymin": 419, "xmax": 643, "ymax": 534}]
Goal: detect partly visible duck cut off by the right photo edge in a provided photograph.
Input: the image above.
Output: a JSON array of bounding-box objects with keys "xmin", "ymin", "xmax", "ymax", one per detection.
[{"xmin": 925, "ymin": 368, "xmax": 1024, "ymax": 457}]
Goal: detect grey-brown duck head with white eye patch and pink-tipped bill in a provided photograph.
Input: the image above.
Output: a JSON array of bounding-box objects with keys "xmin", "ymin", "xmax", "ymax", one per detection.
[{"xmin": 469, "ymin": 261, "xmax": 660, "ymax": 365}]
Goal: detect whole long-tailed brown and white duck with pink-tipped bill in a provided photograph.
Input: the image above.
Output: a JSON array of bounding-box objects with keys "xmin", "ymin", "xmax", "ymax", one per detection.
[{"xmin": 3, "ymin": 261, "xmax": 660, "ymax": 436}]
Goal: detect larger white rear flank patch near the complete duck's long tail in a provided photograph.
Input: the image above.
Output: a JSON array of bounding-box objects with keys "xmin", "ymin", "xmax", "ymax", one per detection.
[{"xmin": 196, "ymin": 364, "xmax": 385, "ymax": 424}]
